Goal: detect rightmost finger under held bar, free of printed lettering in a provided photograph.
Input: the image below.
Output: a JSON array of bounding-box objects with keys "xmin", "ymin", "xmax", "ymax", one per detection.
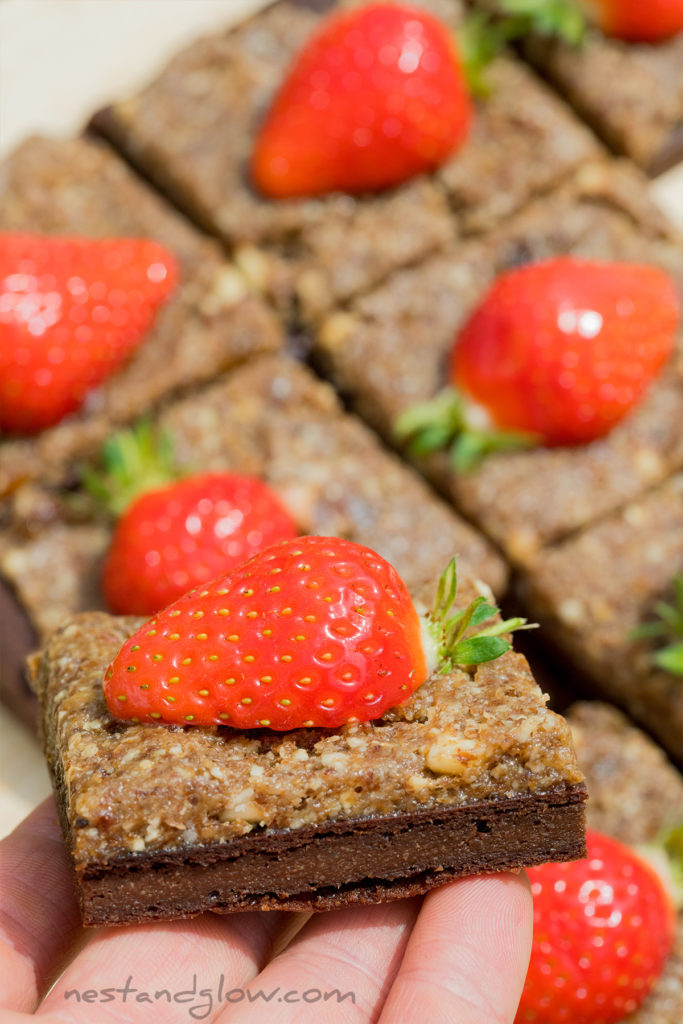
[{"xmin": 380, "ymin": 874, "xmax": 532, "ymax": 1024}]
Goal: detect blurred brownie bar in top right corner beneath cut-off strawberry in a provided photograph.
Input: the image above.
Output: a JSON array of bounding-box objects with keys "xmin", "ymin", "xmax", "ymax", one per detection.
[{"xmin": 525, "ymin": 31, "xmax": 683, "ymax": 174}]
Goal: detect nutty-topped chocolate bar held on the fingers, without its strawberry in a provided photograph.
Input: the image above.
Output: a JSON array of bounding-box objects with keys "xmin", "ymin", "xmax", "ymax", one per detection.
[{"xmin": 33, "ymin": 587, "xmax": 585, "ymax": 925}]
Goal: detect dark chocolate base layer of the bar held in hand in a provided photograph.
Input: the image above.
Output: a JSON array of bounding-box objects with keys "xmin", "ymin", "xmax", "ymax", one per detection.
[{"xmin": 66, "ymin": 784, "xmax": 586, "ymax": 926}]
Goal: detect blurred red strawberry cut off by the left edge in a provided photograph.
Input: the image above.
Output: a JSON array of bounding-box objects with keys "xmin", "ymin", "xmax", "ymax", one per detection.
[{"xmin": 0, "ymin": 233, "xmax": 178, "ymax": 433}]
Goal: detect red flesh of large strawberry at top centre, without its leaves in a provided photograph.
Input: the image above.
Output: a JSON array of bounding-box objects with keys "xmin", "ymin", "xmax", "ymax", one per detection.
[{"xmin": 252, "ymin": 3, "xmax": 472, "ymax": 199}]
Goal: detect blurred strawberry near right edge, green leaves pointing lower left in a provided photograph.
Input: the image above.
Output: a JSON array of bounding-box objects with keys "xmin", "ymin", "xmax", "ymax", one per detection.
[{"xmin": 396, "ymin": 257, "xmax": 679, "ymax": 469}]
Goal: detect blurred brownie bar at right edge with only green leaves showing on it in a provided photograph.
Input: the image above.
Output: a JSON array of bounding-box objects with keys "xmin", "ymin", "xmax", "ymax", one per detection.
[{"xmin": 520, "ymin": 471, "xmax": 683, "ymax": 760}]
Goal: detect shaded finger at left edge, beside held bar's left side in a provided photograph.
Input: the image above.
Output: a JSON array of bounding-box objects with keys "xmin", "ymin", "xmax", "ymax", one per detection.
[{"xmin": 0, "ymin": 797, "xmax": 81, "ymax": 1011}]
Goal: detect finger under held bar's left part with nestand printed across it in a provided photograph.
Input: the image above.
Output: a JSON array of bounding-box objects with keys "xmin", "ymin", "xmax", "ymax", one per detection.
[{"xmin": 38, "ymin": 911, "xmax": 288, "ymax": 1024}]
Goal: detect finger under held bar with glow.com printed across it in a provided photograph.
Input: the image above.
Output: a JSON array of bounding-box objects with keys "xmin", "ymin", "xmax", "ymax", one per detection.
[{"xmin": 219, "ymin": 900, "xmax": 420, "ymax": 1024}]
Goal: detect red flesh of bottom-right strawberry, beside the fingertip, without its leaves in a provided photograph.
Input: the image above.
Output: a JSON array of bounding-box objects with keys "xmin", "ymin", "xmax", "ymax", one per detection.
[{"xmin": 515, "ymin": 831, "xmax": 675, "ymax": 1024}]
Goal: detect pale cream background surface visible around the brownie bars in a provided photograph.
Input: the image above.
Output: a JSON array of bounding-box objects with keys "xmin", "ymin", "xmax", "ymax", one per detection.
[{"xmin": 0, "ymin": 0, "xmax": 683, "ymax": 836}]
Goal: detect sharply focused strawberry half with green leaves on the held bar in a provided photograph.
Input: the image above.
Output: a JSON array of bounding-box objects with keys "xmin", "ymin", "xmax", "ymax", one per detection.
[{"xmin": 103, "ymin": 537, "xmax": 525, "ymax": 730}]
